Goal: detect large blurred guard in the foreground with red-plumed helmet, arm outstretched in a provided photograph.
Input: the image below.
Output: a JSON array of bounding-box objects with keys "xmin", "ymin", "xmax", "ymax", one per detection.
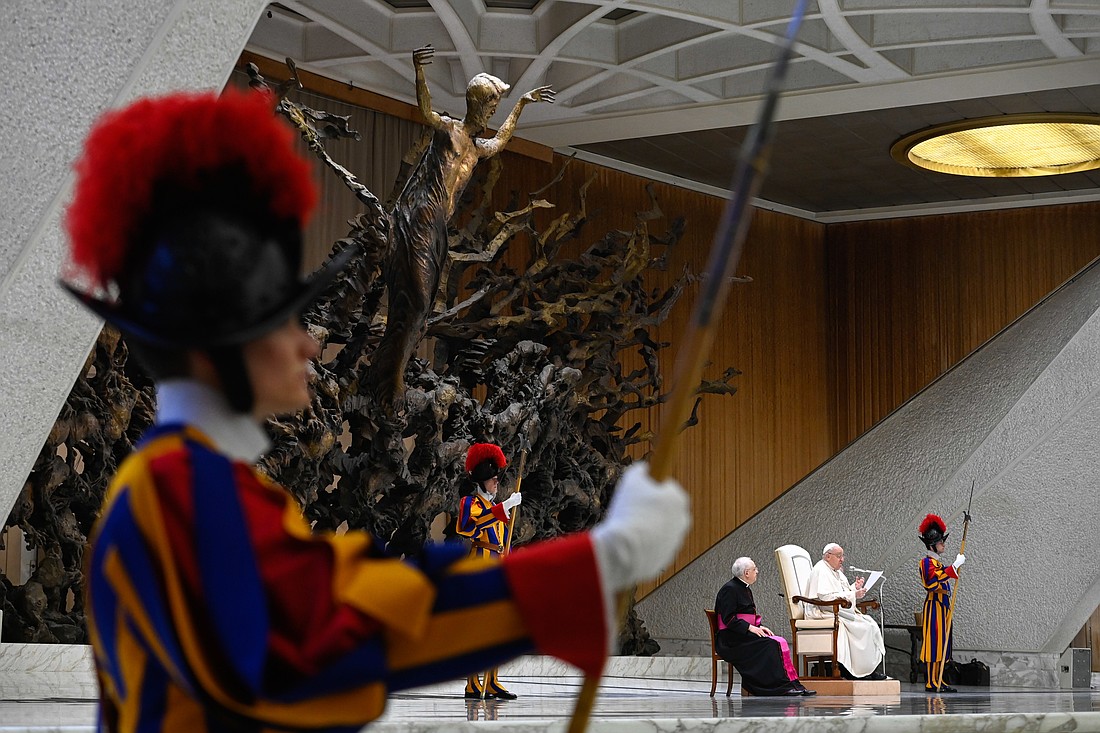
[{"xmin": 66, "ymin": 91, "xmax": 690, "ymax": 733}]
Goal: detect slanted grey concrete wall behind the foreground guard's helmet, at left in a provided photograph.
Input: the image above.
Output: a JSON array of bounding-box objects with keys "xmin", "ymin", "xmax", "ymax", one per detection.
[{"xmin": 0, "ymin": 0, "xmax": 267, "ymax": 537}]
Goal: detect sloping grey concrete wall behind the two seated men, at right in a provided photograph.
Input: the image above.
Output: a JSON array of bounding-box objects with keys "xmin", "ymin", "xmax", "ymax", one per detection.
[{"xmin": 638, "ymin": 258, "xmax": 1100, "ymax": 654}]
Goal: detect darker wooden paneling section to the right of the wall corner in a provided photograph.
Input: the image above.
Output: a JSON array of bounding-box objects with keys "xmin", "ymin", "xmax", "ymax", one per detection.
[{"xmin": 826, "ymin": 204, "xmax": 1100, "ymax": 446}]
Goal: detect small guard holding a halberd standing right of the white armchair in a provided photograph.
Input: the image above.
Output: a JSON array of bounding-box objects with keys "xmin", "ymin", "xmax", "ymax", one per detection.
[{"xmin": 920, "ymin": 514, "xmax": 966, "ymax": 692}]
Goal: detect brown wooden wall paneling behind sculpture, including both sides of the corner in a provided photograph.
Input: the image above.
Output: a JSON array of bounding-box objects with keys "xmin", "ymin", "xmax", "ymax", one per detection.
[{"xmin": 448, "ymin": 158, "xmax": 1096, "ymax": 597}]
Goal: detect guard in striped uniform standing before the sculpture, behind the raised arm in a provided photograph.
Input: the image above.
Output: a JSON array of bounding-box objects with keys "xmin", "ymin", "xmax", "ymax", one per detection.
[{"xmin": 454, "ymin": 442, "xmax": 523, "ymax": 700}]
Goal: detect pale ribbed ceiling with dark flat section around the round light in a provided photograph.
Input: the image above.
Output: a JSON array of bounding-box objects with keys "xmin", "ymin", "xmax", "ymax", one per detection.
[{"xmin": 248, "ymin": 0, "xmax": 1100, "ymax": 221}]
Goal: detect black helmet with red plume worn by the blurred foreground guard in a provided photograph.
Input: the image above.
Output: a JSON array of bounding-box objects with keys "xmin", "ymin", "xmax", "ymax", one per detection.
[{"xmin": 63, "ymin": 90, "xmax": 353, "ymax": 349}]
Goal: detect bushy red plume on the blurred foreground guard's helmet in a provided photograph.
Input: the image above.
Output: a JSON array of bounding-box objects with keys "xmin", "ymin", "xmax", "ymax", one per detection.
[{"xmin": 65, "ymin": 88, "xmax": 317, "ymax": 287}]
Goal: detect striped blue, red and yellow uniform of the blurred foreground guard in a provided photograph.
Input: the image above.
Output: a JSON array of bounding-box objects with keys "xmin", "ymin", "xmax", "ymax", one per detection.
[{"xmin": 87, "ymin": 411, "xmax": 608, "ymax": 733}]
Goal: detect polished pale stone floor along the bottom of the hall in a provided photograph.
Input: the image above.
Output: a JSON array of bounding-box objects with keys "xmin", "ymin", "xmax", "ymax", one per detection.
[{"xmin": 0, "ymin": 677, "xmax": 1100, "ymax": 733}]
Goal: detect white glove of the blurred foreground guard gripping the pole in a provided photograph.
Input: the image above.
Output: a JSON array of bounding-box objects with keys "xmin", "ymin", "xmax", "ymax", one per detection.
[{"xmin": 592, "ymin": 463, "xmax": 691, "ymax": 591}]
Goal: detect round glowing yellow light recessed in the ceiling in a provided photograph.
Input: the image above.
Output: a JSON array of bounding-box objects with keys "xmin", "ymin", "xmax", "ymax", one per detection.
[{"xmin": 890, "ymin": 112, "xmax": 1100, "ymax": 178}]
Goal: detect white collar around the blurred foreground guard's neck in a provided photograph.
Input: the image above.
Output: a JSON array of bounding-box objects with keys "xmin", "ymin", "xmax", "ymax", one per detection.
[{"xmin": 156, "ymin": 380, "xmax": 271, "ymax": 463}]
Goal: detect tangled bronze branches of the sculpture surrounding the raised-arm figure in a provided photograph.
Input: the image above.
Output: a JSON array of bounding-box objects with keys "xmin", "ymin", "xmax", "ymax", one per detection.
[{"xmin": 0, "ymin": 57, "xmax": 736, "ymax": 653}]
